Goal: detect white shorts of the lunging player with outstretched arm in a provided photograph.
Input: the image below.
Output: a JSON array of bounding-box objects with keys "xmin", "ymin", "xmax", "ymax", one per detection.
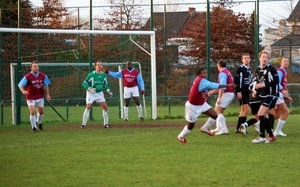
[{"xmin": 185, "ymin": 101, "xmax": 211, "ymax": 123}]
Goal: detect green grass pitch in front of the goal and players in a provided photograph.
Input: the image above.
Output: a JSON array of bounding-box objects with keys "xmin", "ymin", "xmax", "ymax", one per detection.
[{"xmin": 0, "ymin": 114, "xmax": 300, "ymax": 187}]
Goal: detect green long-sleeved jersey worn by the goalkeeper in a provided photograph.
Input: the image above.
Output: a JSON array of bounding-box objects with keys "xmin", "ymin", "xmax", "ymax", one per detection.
[{"xmin": 82, "ymin": 71, "xmax": 110, "ymax": 92}]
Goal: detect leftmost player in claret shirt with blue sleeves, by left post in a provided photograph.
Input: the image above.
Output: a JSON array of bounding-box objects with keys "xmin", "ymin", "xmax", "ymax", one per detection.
[{"xmin": 18, "ymin": 61, "xmax": 50, "ymax": 132}]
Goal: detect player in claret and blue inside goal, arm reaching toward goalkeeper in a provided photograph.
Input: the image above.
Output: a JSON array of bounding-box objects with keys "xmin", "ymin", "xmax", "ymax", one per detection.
[{"xmin": 103, "ymin": 61, "xmax": 145, "ymax": 121}]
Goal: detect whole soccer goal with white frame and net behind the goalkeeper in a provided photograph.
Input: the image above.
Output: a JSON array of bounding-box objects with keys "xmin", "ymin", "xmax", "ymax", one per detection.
[{"xmin": 0, "ymin": 28, "xmax": 157, "ymax": 124}]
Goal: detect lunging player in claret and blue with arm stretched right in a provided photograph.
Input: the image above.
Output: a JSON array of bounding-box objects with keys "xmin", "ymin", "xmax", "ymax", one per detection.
[{"xmin": 177, "ymin": 68, "xmax": 235, "ymax": 143}]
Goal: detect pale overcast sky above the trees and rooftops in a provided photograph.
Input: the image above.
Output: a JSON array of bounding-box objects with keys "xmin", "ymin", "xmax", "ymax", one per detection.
[{"xmin": 31, "ymin": 0, "xmax": 298, "ymax": 33}]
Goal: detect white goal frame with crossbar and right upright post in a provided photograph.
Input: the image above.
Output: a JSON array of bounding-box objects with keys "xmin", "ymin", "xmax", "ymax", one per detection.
[{"xmin": 0, "ymin": 28, "xmax": 157, "ymax": 124}]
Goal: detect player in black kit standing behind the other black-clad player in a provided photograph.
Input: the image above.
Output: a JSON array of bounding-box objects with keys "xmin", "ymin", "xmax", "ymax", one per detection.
[{"xmin": 234, "ymin": 53, "xmax": 252, "ymax": 133}]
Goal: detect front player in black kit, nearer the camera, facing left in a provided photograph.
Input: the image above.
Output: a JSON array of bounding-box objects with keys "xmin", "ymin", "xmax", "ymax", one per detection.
[{"xmin": 252, "ymin": 51, "xmax": 279, "ymax": 143}]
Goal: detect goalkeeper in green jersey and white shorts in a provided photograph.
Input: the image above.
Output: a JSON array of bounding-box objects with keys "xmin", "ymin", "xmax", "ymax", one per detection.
[{"xmin": 81, "ymin": 61, "xmax": 113, "ymax": 129}]
